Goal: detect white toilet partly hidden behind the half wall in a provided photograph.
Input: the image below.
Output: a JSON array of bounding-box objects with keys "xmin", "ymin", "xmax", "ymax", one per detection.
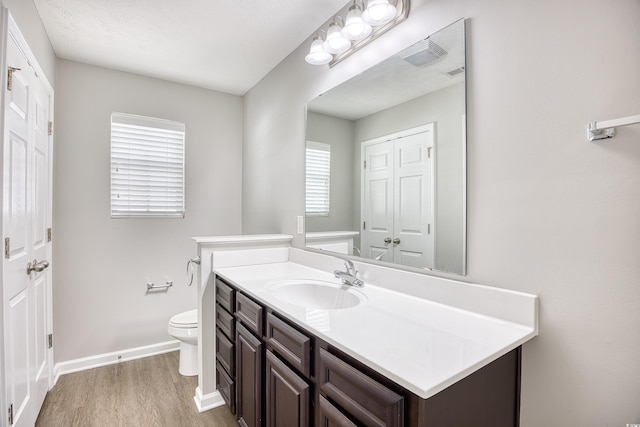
[{"xmin": 167, "ymin": 310, "xmax": 198, "ymax": 376}]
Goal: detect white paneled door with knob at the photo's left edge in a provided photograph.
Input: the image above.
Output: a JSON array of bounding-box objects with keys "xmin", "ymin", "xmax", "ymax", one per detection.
[{"xmin": 2, "ymin": 14, "xmax": 52, "ymax": 426}]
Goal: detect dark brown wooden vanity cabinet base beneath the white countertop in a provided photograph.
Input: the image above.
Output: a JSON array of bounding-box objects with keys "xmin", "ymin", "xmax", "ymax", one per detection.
[{"xmin": 216, "ymin": 278, "xmax": 521, "ymax": 427}]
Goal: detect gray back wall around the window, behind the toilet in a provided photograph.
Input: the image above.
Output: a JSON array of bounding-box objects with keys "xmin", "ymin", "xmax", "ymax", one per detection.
[{"xmin": 53, "ymin": 60, "xmax": 242, "ymax": 362}]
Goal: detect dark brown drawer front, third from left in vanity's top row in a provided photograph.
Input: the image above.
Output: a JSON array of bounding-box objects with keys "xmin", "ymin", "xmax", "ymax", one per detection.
[{"xmin": 265, "ymin": 313, "xmax": 311, "ymax": 378}]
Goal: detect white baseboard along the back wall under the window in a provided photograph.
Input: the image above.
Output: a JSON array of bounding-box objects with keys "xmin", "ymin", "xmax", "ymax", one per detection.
[{"xmin": 53, "ymin": 340, "xmax": 180, "ymax": 385}]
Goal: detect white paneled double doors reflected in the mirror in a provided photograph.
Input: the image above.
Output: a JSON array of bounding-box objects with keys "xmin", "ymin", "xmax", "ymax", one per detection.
[{"xmin": 361, "ymin": 124, "xmax": 435, "ymax": 268}]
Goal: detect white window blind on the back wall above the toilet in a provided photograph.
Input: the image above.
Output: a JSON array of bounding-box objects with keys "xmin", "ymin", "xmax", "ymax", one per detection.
[{"xmin": 111, "ymin": 113, "xmax": 185, "ymax": 218}]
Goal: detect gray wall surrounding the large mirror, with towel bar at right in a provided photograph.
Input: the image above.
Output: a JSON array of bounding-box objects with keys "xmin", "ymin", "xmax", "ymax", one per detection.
[{"xmin": 243, "ymin": 0, "xmax": 640, "ymax": 427}]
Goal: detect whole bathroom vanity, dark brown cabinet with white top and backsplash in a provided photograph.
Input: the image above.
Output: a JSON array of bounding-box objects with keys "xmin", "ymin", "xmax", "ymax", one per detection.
[{"xmin": 202, "ymin": 241, "xmax": 537, "ymax": 427}]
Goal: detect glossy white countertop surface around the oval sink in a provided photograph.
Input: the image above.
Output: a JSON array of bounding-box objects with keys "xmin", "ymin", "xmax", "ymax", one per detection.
[{"xmin": 215, "ymin": 261, "xmax": 537, "ymax": 398}]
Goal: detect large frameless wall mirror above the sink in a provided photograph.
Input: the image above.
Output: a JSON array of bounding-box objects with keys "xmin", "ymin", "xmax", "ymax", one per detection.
[{"xmin": 305, "ymin": 20, "xmax": 466, "ymax": 275}]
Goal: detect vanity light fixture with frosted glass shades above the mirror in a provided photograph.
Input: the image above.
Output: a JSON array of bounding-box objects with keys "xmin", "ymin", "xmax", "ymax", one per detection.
[{"xmin": 305, "ymin": 0, "xmax": 409, "ymax": 66}]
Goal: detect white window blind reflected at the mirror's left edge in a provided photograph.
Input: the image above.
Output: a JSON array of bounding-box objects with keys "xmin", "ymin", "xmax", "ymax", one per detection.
[{"xmin": 306, "ymin": 141, "xmax": 331, "ymax": 216}]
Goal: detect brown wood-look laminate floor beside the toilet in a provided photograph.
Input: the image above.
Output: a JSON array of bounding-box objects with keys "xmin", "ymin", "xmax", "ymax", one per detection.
[{"xmin": 36, "ymin": 352, "xmax": 238, "ymax": 427}]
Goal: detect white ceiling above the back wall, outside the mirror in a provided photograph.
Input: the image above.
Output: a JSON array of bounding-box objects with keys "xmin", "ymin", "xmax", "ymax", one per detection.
[{"xmin": 33, "ymin": 0, "xmax": 348, "ymax": 95}]
